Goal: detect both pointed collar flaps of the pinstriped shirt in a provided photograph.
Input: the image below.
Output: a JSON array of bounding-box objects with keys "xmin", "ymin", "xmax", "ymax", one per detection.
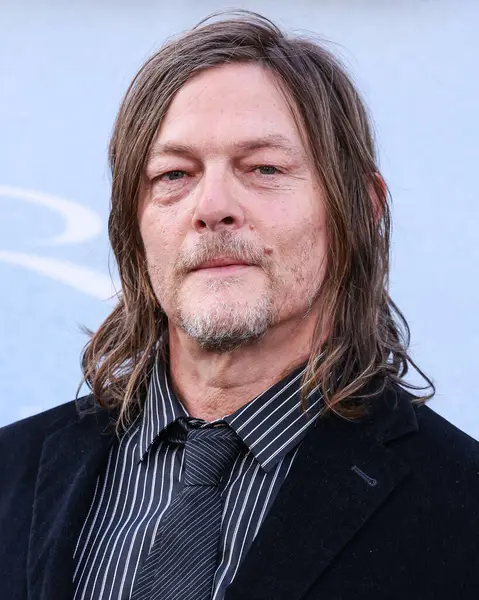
[{"xmin": 137, "ymin": 360, "xmax": 322, "ymax": 471}]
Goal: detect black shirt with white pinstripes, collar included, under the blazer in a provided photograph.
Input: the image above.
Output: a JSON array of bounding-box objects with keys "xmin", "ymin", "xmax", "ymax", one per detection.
[{"xmin": 73, "ymin": 363, "xmax": 321, "ymax": 600}]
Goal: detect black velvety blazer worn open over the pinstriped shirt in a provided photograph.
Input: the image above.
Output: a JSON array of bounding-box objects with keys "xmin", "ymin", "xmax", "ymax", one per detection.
[{"xmin": 0, "ymin": 387, "xmax": 479, "ymax": 600}]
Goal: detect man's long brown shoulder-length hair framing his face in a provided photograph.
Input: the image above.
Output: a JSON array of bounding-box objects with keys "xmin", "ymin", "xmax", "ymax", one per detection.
[{"xmin": 82, "ymin": 11, "xmax": 435, "ymax": 429}]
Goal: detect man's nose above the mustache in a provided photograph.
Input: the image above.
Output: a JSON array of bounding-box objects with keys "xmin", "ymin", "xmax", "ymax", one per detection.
[{"xmin": 192, "ymin": 171, "xmax": 245, "ymax": 233}]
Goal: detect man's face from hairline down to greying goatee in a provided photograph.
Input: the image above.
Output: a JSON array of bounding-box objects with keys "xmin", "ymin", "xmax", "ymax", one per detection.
[{"xmin": 138, "ymin": 64, "xmax": 326, "ymax": 352}]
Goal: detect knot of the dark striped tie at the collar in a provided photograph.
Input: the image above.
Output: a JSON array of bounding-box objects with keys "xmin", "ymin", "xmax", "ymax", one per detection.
[{"xmin": 185, "ymin": 425, "xmax": 243, "ymax": 485}]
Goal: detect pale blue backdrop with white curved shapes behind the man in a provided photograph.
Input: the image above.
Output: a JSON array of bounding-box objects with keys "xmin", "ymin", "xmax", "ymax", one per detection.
[{"xmin": 0, "ymin": 0, "xmax": 479, "ymax": 439}]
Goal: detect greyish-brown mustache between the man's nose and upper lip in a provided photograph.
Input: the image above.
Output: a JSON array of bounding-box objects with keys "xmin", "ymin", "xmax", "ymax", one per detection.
[{"xmin": 176, "ymin": 232, "xmax": 271, "ymax": 274}]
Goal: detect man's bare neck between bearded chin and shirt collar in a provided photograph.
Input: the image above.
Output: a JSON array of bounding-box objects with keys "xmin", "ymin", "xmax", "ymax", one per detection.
[{"xmin": 169, "ymin": 315, "xmax": 315, "ymax": 421}]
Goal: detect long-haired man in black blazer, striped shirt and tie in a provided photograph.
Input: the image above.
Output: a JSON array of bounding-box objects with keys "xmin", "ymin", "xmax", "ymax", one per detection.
[{"xmin": 0, "ymin": 13, "xmax": 479, "ymax": 600}]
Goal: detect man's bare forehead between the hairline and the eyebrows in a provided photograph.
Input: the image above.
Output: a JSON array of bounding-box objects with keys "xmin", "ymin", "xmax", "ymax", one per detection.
[{"xmin": 149, "ymin": 63, "xmax": 316, "ymax": 158}]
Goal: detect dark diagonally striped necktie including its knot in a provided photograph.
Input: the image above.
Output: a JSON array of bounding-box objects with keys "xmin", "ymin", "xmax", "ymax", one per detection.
[{"xmin": 131, "ymin": 419, "xmax": 243, "ymax": 600}]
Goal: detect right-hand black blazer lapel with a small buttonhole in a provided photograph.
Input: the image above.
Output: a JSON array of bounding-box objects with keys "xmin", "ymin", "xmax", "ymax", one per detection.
[{"xmin": 225, "ymin": 390, "xmax": 418, "ymax": 600}]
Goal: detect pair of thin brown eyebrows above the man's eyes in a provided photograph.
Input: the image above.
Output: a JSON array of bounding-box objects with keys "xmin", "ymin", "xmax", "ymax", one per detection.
[{"xmin": 148, "ymin": 133, "xmax": 305, "ymax": 161}]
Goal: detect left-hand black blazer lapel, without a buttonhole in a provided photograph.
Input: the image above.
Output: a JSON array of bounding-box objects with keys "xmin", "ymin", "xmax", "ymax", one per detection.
[{"xmin": 27, "ymin": 398, "xmax": 114, "ymax": 600}]
